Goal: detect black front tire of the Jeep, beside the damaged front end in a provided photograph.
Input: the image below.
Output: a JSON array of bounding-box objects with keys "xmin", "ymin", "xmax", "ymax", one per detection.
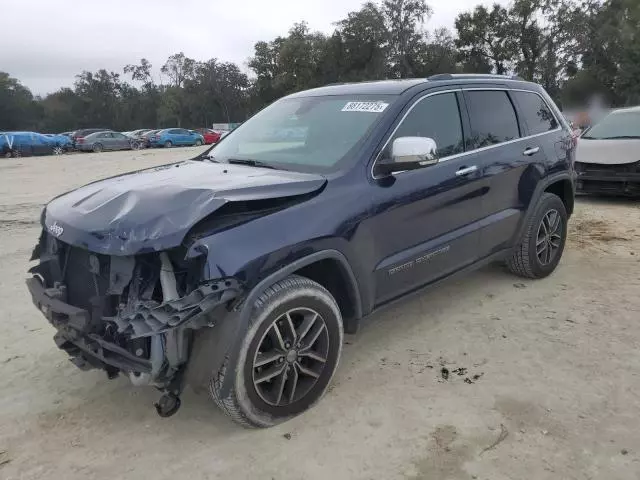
[{"xmin": 209, "ymin": 275, "xmax": 343, "ymax": 428}]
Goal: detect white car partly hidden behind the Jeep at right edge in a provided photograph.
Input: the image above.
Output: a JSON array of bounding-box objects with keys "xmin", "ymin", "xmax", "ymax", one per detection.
[{"xmin": 575, "ymin": 107, "xmax": 640, "ymax": 196}]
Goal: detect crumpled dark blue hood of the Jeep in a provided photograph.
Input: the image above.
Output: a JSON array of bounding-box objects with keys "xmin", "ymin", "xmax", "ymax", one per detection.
[{"xmin": 43, "ymin": 161, "xmax": 326, "ymax": 255}]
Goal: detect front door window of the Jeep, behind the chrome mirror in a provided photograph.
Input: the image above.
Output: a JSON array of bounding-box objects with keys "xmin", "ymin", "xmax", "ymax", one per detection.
[{"xmin": 386, "ymin": 93, "xmax": 464, "ymax": 158}]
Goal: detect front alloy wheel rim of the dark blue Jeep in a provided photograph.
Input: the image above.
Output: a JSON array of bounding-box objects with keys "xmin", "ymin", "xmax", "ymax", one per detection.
[{"xmin": 252, "ymin": 308, "xmax": 329, "ymax": 407}]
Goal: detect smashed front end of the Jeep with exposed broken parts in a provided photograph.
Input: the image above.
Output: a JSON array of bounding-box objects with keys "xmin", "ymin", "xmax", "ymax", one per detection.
[{"xmin": 27, "ymin": 231, "xmax": 242, "ymax": 416}]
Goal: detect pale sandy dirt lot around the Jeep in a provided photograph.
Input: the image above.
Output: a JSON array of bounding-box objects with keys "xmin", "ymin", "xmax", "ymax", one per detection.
[{"xmin": 0, "ymin": 149, "xmax": 640, "ymax": 480}]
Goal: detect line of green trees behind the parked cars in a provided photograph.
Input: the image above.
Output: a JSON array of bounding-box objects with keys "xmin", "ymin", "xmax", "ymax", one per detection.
[{"xmin": 0, "ymin": 0, "xmax": 640, "ymax": 132}]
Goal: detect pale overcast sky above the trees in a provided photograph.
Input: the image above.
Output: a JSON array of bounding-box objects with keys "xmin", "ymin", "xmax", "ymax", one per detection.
[{"xmin": 0, "ymin": 0, "xmax": 506, "ymax": 95}]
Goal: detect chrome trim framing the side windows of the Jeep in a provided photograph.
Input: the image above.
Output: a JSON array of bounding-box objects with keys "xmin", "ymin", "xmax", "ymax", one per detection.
[{"xmin": 371, "ymin": 87, "xmax": 568, "ymax": 180}]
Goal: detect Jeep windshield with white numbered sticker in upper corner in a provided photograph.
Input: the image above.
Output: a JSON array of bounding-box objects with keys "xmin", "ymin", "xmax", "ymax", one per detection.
[{"xmin": 207, "ymin": 95, "xmax": 396, "ymax": 172}]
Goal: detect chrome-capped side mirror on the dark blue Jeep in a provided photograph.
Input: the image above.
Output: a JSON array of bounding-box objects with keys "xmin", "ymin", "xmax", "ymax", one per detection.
[{"xmin": 376, "ymin": 137, "xmax": 438, "ymax": 175}]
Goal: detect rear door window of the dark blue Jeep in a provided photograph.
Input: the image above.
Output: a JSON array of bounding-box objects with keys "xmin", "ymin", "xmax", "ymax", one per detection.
[{"xmin": 466, "ymin": 90, "xmax": 520, "ymax": 148}]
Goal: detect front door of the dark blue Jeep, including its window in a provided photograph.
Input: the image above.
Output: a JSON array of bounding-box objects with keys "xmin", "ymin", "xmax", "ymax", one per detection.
[{"xmin": 366, "ymin": 92, "xmax": 488, "ymax": 305}]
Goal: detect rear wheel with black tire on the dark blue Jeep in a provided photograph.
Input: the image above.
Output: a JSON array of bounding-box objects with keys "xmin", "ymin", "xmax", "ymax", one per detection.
[{"xmin": 507, "ymin": 193, "xmax": 568, "ymax": 278}]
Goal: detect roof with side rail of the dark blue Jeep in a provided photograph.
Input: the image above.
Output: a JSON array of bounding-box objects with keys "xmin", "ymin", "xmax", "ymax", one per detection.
[{"xmin": 286, "ymin": 73, "xmax": 540, "ymax": 98}]
